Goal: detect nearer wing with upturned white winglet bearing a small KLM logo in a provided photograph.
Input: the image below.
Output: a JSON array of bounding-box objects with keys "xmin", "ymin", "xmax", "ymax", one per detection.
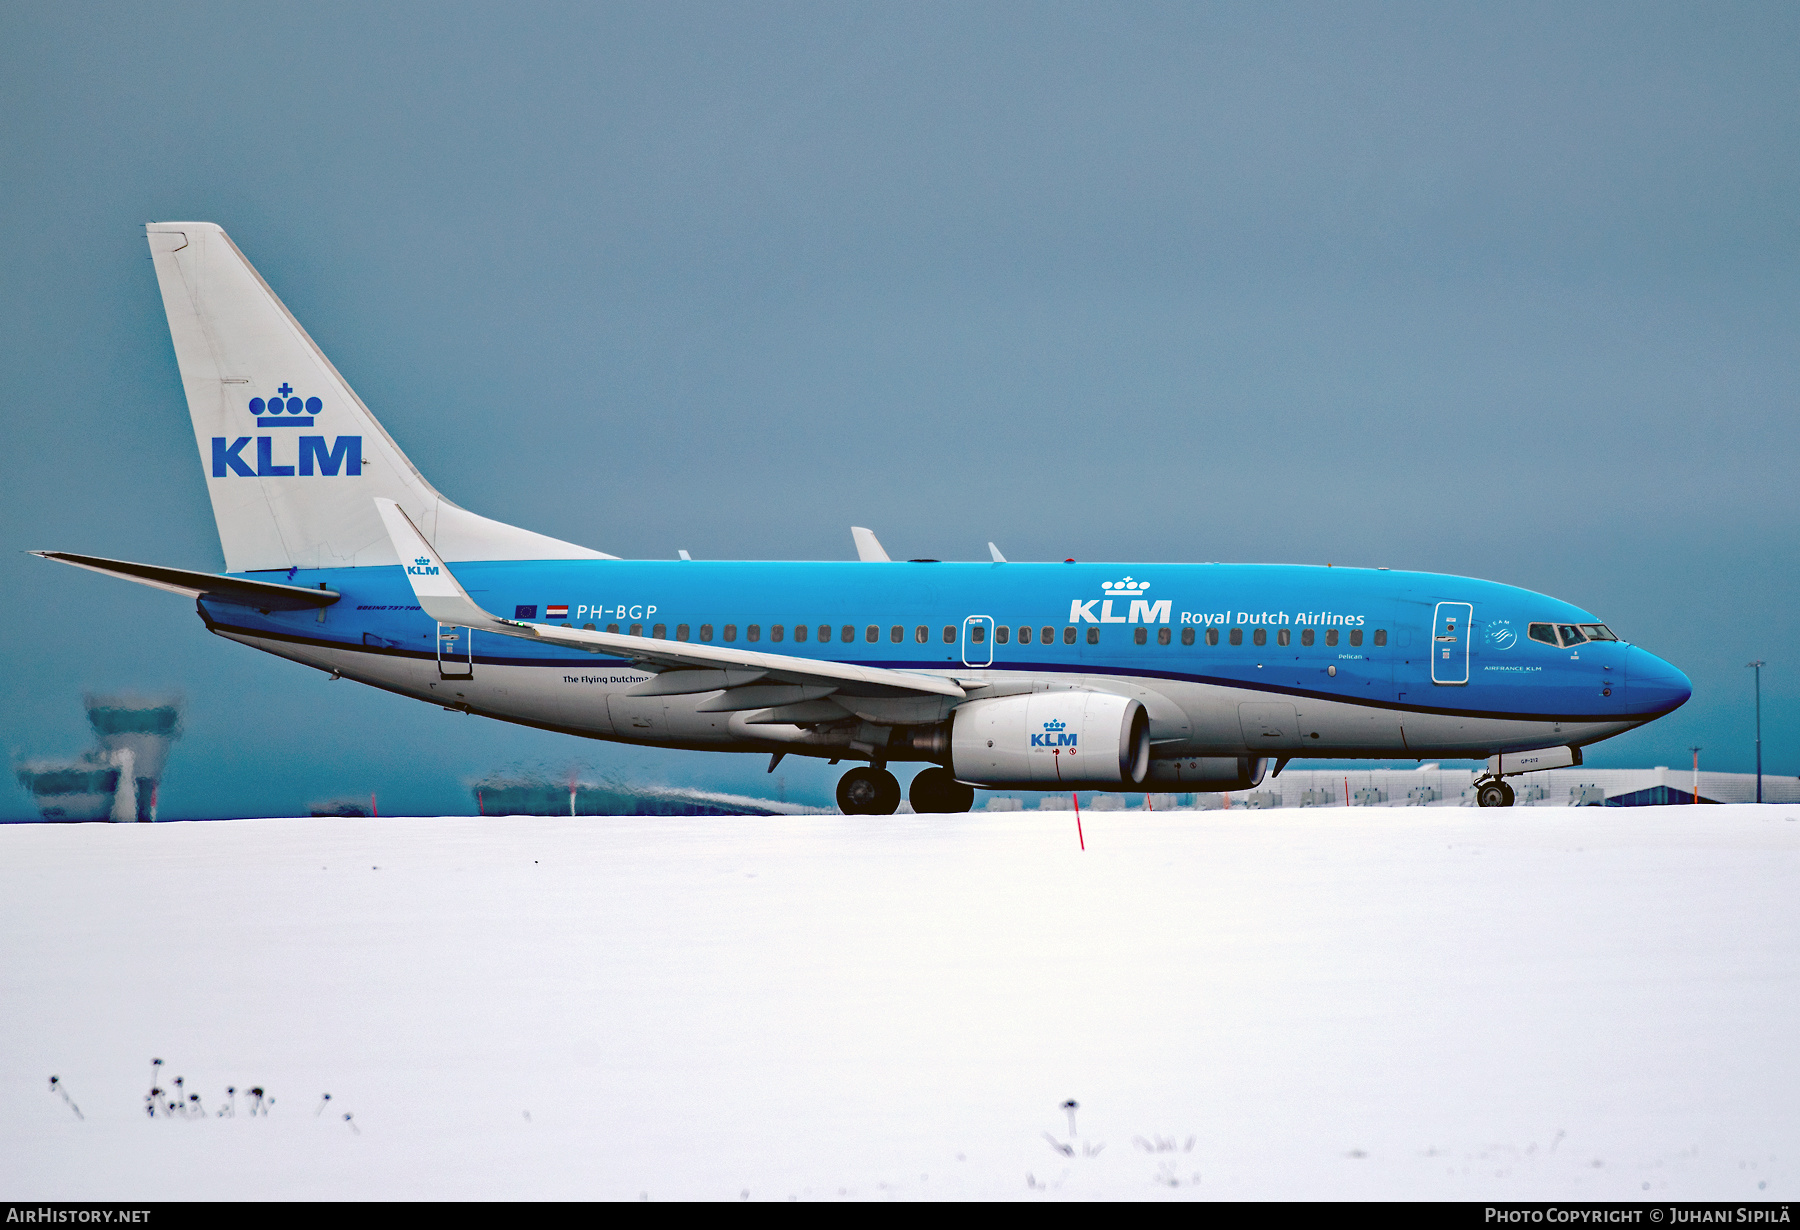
[{"xmin": 374, "ymin": 499, "xmax": 967, "ymax": 701}]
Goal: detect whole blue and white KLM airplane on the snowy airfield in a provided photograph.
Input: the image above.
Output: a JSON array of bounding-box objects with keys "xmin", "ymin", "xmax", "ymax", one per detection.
[{"xmin": 40, "ymin": 222, "xmax": 1690, "ymax": 814}]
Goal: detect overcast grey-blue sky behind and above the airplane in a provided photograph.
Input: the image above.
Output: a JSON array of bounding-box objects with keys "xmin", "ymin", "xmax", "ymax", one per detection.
[{"xmin": 0, "ymin": 4, "xmax": 1800, "ymax": 814}]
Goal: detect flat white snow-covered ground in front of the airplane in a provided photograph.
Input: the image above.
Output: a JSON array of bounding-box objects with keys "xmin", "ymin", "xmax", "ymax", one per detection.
[{"xmin": 0, "ymin": 805, "xmax": 1800, "ymax": 1201}]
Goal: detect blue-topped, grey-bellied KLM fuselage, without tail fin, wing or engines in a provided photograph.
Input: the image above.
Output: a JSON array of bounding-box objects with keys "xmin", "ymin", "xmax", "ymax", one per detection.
[{"xmin": 203, "ymin": 560, "xmax": 1690, "ymax": 756}]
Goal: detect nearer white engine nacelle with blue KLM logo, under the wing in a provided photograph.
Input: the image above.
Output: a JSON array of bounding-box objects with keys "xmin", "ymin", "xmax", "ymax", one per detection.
[{"xmin": 950, "ymin": 692, "xmax": 1150, "ymax": 791}]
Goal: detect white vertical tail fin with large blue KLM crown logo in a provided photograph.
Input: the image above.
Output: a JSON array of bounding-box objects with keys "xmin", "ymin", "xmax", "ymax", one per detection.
[{"xmin": 146, "ymin": 222, "xmax": 612, "ymax": 573}]
